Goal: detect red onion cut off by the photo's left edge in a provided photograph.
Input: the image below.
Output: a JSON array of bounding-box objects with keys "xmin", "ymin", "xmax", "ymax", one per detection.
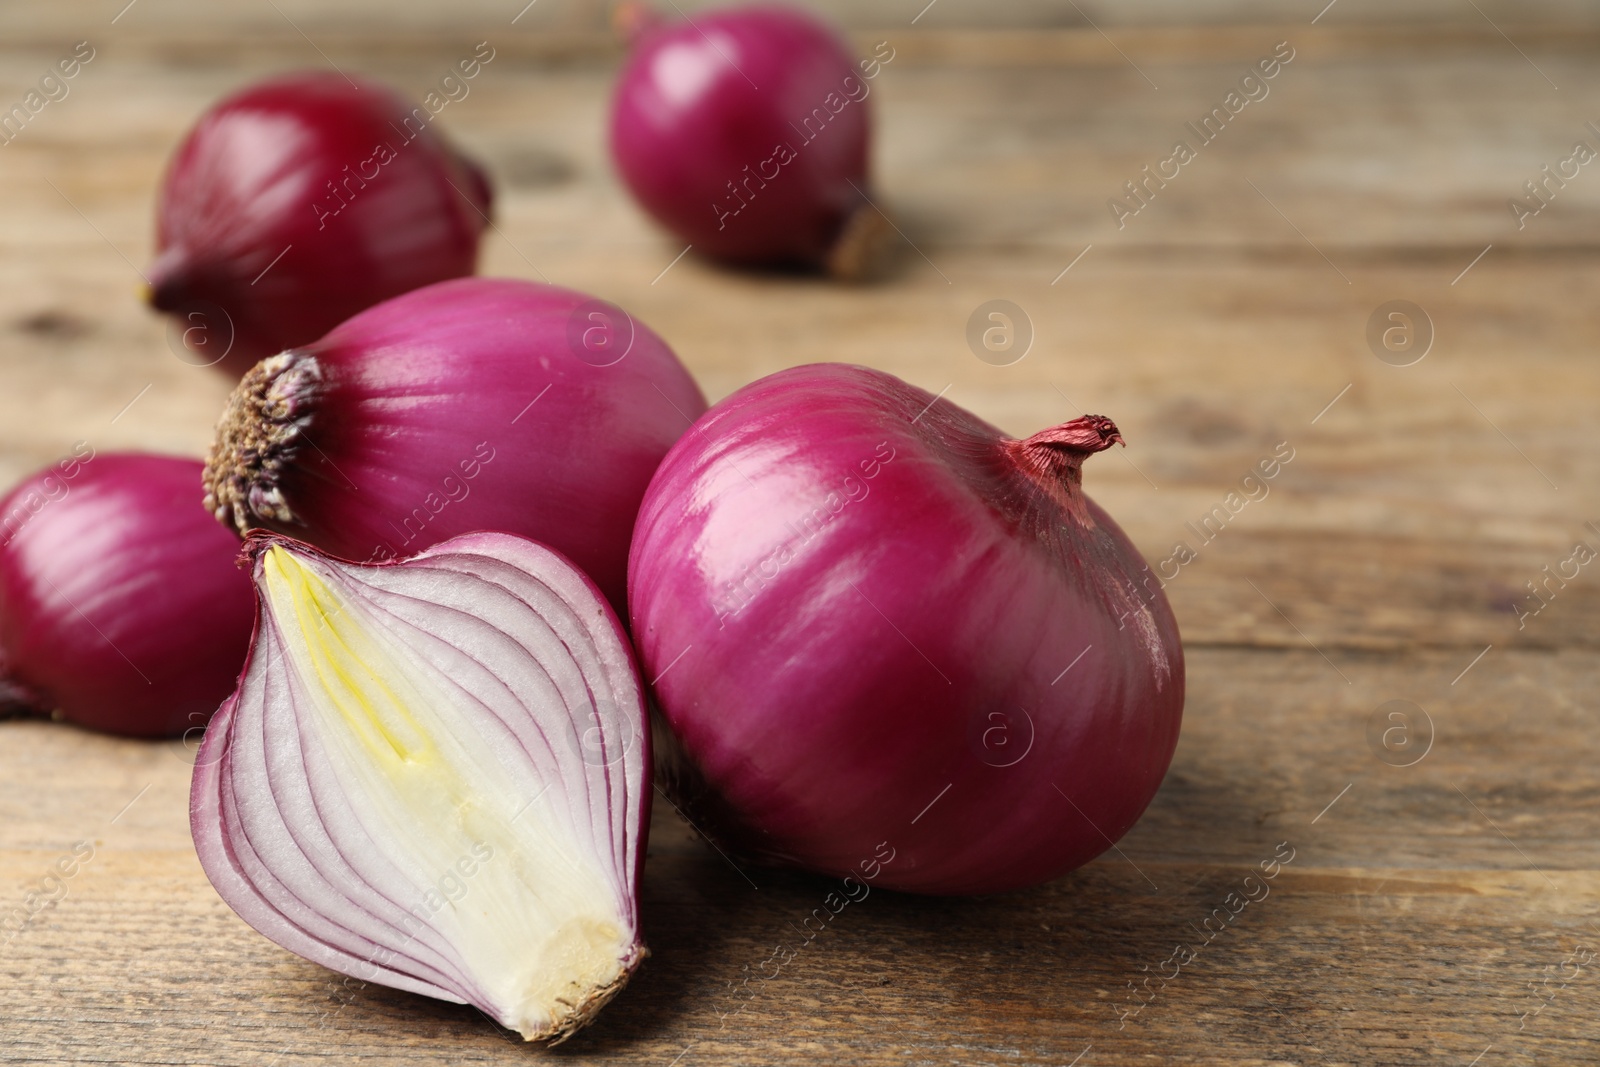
[{"xmin": 0, "ymin": 450, "xmax": 254, "ymax": 737}]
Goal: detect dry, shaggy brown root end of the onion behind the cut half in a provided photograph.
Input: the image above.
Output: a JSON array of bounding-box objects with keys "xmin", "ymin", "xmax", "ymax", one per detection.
[{"xmin": 202, "ymin": 349, "xmax": 322, "ymax": 533}]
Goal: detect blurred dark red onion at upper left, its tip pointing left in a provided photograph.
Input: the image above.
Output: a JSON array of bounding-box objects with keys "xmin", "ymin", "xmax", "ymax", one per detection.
[{"xmin": 149, "ymin": 72, "xmax": 491, "ymax": 376}]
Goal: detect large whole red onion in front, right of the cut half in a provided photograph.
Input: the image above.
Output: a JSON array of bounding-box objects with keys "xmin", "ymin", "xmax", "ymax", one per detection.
[{"xmin": 629, "ymin": 365, "xmax": 1184, "ymax": 894}]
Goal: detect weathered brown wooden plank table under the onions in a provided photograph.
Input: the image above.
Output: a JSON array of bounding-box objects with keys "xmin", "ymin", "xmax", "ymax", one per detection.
[{"xmin": 0, "ymin": 0, "xmax": 1600, "ymax": 1067}]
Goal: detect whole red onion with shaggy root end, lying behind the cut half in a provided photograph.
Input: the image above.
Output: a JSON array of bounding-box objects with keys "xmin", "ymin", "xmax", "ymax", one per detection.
[{"xmin": 205, "ymin": 278, "xmax": 706, "ymax": 609}]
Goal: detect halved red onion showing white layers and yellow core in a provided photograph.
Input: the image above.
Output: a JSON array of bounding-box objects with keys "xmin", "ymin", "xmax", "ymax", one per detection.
[{"xmin": 190, "ymin": 533, "xmax": 650, "ymax": 1045}]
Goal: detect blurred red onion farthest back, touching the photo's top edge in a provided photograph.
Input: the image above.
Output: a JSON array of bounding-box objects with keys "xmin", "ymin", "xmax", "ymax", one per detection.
[{"xmin": 611, "ymin": 5, "xmax": 872, "ymax": 267}]
